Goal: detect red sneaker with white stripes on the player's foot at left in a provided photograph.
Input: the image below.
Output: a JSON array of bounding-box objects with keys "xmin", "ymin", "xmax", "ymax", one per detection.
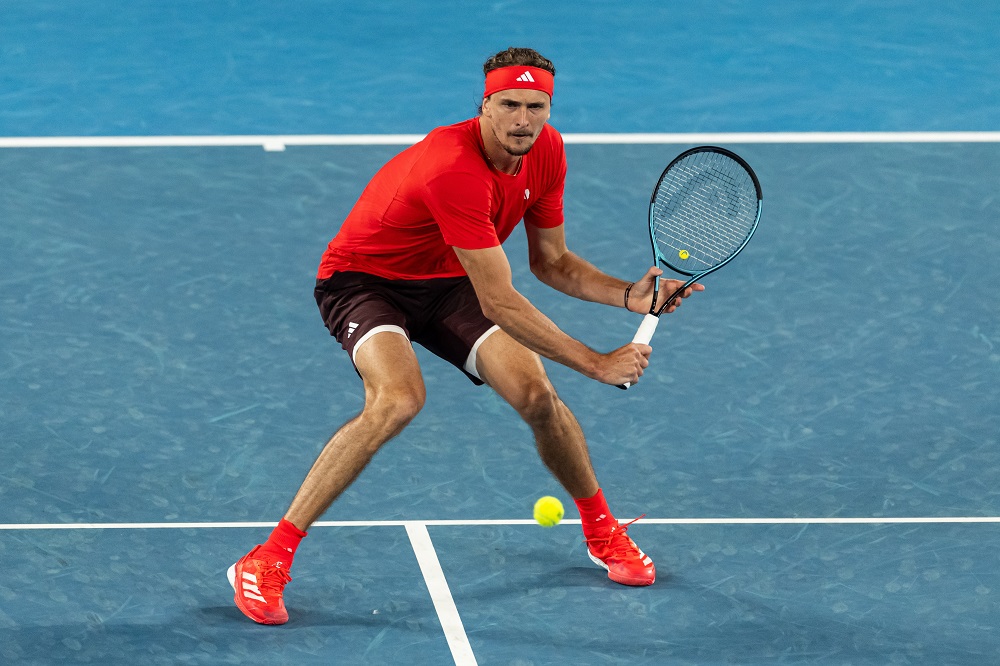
[{"xmin": 227, "ymin": 545, "xmax": 292, "ymax": 624}]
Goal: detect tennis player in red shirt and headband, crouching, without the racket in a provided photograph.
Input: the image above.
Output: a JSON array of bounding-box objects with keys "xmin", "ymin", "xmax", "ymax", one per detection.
[{"xmin": 229, "ymin": 48, "xmax": 702, "ymax": 624}]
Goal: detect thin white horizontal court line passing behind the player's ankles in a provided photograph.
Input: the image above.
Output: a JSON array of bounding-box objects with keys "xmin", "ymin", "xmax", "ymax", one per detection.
[{"xmin": 0, "ymin": 516, "xmax": 1000, "ymax": 530}]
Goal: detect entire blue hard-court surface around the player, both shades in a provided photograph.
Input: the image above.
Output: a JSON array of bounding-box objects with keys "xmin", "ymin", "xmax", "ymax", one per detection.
[{"xmin": 0, "ymin": 2, "xmax": 1000, "ymax": 666}]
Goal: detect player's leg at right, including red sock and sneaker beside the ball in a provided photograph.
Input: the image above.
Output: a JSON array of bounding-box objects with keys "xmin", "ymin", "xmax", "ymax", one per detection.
[{"xmin": 476, "ymin": 330, "xmax": 656, "ymax": 585}]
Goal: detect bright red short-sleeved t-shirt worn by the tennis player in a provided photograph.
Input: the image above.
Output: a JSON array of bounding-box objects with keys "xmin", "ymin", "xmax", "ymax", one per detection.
[{"xmin": 317, "ymin": 118, "xmax": 566, "ymax": 280}]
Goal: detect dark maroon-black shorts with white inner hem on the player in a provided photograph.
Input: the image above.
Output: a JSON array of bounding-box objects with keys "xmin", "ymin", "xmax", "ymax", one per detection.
[{"xmin": 314, "ymin": 271, "xmax": 499, "ymax": 384}]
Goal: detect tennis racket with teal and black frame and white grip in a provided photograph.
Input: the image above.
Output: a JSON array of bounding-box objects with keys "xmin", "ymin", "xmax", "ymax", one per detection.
[{"xmin": 619, "ymin": 146, "xmax": 763, "ymax": 389}]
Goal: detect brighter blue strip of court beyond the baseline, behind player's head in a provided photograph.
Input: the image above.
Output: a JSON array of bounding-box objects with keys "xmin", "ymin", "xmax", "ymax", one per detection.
[{"xmin": 0, "ymin": 0, "xmax": 1000, "ymax": 136}]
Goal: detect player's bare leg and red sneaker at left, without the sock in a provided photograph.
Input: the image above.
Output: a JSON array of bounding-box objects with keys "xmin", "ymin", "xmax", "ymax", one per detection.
[{"xmin": 229, "ymin": 332, "xmax": 425, "ymax": 624}]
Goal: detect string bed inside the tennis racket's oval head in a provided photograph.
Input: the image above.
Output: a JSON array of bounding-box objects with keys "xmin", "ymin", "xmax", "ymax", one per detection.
[{"xmin": 651, "ymin": 153, "xmax": 757, "ymax": 272}]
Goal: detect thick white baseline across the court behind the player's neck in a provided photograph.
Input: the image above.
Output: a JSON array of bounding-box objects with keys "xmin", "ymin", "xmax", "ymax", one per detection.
[{"xmin": 0, "ymin": 132, "xmax": 1000, "ymax": 151}]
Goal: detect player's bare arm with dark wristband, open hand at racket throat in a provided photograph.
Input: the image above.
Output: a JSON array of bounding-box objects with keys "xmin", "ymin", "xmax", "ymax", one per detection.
[{"xmin": 524, "ymin": 224, "xmax": 704, "ymax": 314}]
